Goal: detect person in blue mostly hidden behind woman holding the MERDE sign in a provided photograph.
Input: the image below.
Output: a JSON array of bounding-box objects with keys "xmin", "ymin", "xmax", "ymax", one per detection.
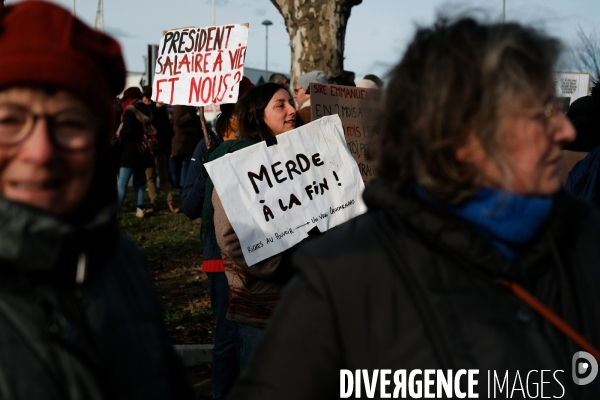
[{"xmin": 181, "ymin": 76, "xmax": 254, "ymax": 400}]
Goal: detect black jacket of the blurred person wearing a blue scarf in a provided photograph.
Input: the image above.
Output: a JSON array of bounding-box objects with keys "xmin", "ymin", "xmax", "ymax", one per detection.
[{"xmin": 230, "ymin": 183, "xmax": 600, "ymax": 400}]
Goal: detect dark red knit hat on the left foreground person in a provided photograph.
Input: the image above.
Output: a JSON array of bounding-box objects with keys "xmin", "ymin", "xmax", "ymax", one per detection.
[{"xmin": 0, "ymin": 0, "xmax": 126, "ymax": 116}]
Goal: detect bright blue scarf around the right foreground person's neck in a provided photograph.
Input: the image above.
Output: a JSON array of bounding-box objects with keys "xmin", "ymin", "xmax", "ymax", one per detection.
[{"xmin": 416, "ymin": 186, "xmax": 553, "ymax": 262}]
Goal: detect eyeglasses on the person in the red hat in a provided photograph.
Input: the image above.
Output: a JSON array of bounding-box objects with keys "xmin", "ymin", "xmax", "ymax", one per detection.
[{"xmin": 0, "ymin": 104, "xmax": 99, "ymax": 151}]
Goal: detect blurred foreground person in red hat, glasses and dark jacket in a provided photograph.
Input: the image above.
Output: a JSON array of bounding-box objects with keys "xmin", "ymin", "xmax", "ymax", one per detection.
[{"xmin": 0, "ymin": 1, "xmax": 193, "ymax": 400}]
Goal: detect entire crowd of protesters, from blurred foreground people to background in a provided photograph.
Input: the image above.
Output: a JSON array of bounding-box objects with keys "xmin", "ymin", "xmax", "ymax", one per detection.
[{"xmin": 0, "ymin": 0, "xmax": 600, "ymax": 400}]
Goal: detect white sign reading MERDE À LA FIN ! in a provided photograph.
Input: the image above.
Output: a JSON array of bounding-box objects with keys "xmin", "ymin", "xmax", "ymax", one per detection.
[{"xmin": 205, "ymin": 115, "xmax": 366, "ymax": 265}]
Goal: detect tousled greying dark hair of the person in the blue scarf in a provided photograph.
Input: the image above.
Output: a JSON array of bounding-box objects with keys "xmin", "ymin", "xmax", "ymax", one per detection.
[{"xmin": 377, "ymin": 17, "xmax": 560, "ymax": 203}]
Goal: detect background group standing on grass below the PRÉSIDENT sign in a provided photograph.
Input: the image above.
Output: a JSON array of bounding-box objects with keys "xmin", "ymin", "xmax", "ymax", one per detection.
[{"xmin": 113, "ymin": 86, "xmax": 202, "ymax": 218}]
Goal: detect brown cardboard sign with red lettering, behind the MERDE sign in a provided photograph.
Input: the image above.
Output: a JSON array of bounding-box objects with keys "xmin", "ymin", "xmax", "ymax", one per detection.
[{"xmin": 310, "ymin": 83, "xmax": 380, "ymax": 182}]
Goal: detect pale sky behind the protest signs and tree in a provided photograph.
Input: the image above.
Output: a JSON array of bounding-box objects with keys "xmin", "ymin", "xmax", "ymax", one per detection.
[{"xmin": 7, "ymin": 0, "xmax": 600, "ymax": 79}]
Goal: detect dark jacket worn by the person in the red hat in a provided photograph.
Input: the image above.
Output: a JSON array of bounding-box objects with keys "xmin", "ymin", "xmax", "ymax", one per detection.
[{"xmin": 0, "ymin": 197, "xmax": 192, "ymax": 400}]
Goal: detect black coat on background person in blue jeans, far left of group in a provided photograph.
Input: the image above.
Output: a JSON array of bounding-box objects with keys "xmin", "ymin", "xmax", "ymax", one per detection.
[{"xmin": 120, "ymin": 102, "xmax": 153, "ymax": 170}]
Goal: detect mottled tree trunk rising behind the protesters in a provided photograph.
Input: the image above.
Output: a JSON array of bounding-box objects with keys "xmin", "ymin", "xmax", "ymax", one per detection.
[{"xmin": 271, "ymin": 0, "xmax": 362, "ymax": 83}]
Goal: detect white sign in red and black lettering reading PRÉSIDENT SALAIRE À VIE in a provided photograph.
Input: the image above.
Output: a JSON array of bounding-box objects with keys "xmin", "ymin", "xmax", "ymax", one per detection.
[{"xmin": 152, "ymin": 25, "xmax": 248, "ymax": 106}]
